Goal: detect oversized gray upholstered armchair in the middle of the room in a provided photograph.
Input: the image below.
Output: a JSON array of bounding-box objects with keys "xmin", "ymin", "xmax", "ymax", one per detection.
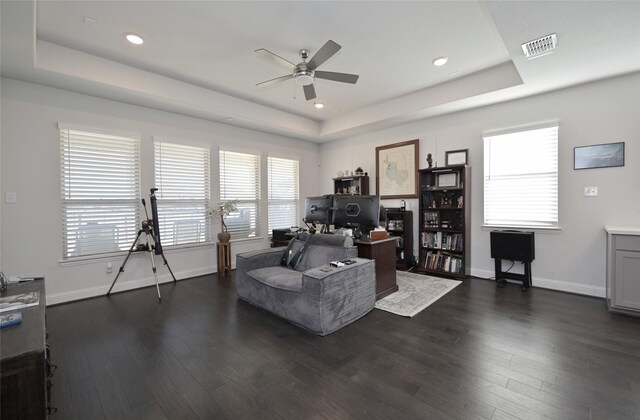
[{"xmin": 236, "ymin": 234, "xmax": 376, "ymax": 335}]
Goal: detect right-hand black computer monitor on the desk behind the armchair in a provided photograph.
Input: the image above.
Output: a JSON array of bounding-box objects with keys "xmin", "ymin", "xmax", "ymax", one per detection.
[{"xmin": 331, "ymin": 195, "xmax": 380, "ymax": 233}]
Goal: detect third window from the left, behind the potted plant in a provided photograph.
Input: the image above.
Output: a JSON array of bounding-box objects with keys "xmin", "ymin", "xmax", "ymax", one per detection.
[{"xmin": 220, "ymin": 150, "xmax": 260, "ymax": 239}]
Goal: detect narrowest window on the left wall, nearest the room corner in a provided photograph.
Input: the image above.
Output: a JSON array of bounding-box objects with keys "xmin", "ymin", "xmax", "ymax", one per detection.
[{"xmin": 267, "ymin": 156, "xmax": 299, "ymax": 232}]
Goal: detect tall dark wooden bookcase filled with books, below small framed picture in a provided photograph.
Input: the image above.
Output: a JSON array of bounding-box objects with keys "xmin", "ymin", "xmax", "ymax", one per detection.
[{"xmin": 418, "ymin": 165, "xmax": 471, "ymax": 279}]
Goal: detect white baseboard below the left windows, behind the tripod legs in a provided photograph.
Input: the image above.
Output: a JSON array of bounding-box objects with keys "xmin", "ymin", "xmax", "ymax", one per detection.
[{"xmin": 47, "ymin": 267, "xmax": 215, "ymax": 305}]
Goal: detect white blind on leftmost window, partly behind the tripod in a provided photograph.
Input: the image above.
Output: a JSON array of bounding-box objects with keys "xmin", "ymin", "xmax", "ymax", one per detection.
[{"xmin": 60, "ymin": 127, "xmax": 140, "ymax": 259}]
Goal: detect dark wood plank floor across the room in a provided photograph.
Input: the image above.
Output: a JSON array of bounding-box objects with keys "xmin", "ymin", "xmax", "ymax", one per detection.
[{"xmin": 47, "ymin": 270, "xmax": 640, "ymax": 420}]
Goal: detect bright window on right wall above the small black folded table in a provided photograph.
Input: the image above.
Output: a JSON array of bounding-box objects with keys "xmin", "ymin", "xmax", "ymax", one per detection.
[{"xmin": 484, "ymin": 125, "xmax": 558, "ymax": 228}]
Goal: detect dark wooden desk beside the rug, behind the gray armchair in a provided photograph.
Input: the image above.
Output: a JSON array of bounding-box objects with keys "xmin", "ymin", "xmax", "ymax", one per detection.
[{"xmin": 354, "ymin": 237, "xmax": 398, "ymax": 300}]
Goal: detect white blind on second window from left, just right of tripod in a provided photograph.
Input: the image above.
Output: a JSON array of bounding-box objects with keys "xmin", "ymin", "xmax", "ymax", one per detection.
[{"xmin": 154, "ymin": 140, "xmax": 211, "ymax": 246}]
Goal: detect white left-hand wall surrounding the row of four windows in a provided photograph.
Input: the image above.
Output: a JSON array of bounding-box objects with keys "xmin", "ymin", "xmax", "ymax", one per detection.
[{"xmin": 0, "ymin": 79, "xmax": 321, "ymax": 303}]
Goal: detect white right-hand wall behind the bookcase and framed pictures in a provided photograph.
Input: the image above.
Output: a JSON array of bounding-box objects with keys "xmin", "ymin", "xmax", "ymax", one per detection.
[{"xmin": 321, "ymin": 73, "xmax": 640, "ymax": 296}]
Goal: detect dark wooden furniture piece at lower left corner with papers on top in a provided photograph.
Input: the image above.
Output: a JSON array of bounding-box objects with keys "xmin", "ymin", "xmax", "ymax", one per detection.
[{"xmin": 0, "ymin": 280, "xmax": 50, "ymax": 420}]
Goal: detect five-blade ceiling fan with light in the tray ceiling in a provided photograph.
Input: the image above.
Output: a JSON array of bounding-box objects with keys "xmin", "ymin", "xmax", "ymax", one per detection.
[{"xmin": 255, "ymin": 40, "xmax": 360, "ymax": 101}]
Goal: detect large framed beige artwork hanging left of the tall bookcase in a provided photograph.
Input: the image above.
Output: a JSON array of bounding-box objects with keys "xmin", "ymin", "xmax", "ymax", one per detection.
[{"xmin": 376, "ymin": 139, "xmax": 419, "ymax": 199}]
